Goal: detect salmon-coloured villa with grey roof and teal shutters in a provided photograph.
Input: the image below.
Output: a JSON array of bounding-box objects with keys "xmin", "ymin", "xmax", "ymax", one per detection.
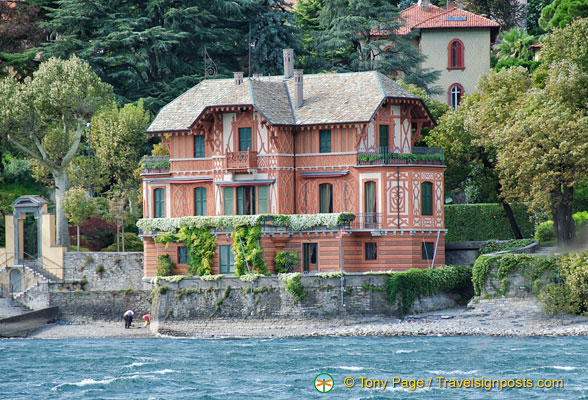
[{"xmin": 142, "ymin": 49, "xmax": 445, "ymax": 276}]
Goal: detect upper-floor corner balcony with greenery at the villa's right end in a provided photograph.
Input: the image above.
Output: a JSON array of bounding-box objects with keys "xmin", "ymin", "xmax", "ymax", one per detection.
[{"xmin": 357, "ymin": 147, "xmax": 445, "ymax": 165}]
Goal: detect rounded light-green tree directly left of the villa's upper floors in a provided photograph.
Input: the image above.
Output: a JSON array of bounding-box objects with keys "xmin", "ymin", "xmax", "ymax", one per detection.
[{"xmin": 88, "ymin": 100, "xmax": 150, "ymax": 185}]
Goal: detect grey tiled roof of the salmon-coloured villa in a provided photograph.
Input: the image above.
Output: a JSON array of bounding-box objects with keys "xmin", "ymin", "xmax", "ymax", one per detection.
[{"xmin": 147, "ymin": 71, "xmax": 419, "ymax": 133}]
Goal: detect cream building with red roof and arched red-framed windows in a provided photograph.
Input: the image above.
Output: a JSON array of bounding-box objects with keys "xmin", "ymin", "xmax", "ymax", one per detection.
[{"xmin": 399, "ymin": 1, "xmax": 500, "ymax": 107}]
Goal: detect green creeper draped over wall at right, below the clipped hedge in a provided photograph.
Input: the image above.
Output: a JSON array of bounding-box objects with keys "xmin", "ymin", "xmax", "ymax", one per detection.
[{"xmin": 472, "ymin": 254, "xmax": 558, "ymax": 296}]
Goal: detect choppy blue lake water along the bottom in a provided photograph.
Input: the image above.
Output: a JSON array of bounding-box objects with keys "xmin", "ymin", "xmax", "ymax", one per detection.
[{"xmin": 0, "ymin": 337, "xmax": 588, "ymax": 399}]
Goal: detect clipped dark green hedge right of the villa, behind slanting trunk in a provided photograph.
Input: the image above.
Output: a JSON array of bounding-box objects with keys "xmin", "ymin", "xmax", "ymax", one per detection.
[{"xmin": 445, "ymin": 203, "xmax": 535, "ymax": 242}]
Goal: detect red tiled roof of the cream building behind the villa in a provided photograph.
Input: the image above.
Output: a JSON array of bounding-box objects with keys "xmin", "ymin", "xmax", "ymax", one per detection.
[{"xmin": 398, "ymin": 4, "xmax": 500, "ymax": 35}]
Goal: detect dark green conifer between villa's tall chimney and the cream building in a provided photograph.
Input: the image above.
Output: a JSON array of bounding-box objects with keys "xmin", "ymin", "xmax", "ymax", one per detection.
[{"xmin": 317, "ymin": 0, "xmax": 439, "ymax": 92}]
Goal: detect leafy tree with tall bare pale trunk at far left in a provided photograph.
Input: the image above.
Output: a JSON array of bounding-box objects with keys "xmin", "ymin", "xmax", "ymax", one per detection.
[{"xmin": 0, "ymin": 56, "xmax": 112, "ymax": 246}]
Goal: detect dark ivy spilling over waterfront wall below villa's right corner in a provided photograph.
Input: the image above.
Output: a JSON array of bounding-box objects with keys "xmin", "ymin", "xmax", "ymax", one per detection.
[{"xmin": 386, "ymin": 265, "xmax": 472, "ymax": 316}]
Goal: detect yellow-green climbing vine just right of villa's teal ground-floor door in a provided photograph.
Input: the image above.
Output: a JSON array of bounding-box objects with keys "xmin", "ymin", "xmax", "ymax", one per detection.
[{"xmin": 231, "ymin": 225, "xmax": 268, "ymax": 276}]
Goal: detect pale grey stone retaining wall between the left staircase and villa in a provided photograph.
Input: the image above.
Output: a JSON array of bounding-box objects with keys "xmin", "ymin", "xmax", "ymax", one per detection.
[{"xmin": 64, "ymin": 252, "xmax": 149, "ymax": 291}]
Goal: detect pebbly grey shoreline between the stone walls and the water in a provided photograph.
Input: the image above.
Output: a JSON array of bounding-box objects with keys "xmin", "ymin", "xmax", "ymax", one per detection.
[{"xmin": 30, "ymin": 298, "xmax": 588, "ymax": 339}]
